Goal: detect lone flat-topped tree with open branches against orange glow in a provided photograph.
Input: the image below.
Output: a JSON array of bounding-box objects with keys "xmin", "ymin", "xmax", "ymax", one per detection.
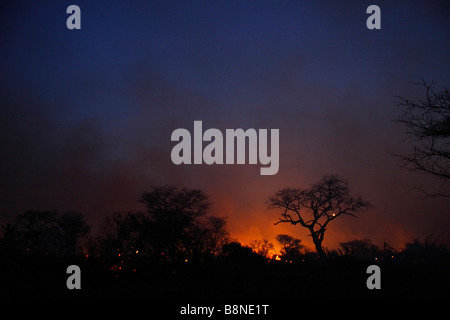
[{"xmin": 268, "ymin": 175, "xmax": 369, "ymax": 258}]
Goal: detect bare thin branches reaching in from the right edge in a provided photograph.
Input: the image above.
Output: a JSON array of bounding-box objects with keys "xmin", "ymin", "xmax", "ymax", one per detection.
[{"xmin": 395, "ymin": 81, "xmax": 450, "ymax": 197}]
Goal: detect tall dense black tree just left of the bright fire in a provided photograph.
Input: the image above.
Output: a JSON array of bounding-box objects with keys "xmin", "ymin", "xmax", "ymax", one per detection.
[{"xmin": 140, "ymin": 186, "xmax": 228, "ymax": 261}]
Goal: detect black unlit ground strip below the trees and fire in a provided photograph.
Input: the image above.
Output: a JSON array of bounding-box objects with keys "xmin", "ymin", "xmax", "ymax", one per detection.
[{"xmin": 0, "ymin": 257, "xmax": 450, "ymax": 303}]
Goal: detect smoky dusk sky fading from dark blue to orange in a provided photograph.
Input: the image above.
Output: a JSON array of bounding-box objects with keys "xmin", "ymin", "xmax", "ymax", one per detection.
[{"xmin": 0, "ymin": 0, "xmax": 450, "ymax": 252}]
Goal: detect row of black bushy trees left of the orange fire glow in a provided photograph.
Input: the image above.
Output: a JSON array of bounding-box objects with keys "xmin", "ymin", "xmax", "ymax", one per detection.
[{"xmin": 0, "ymin": 186, "xmax": 229, "ymax": 262}]
